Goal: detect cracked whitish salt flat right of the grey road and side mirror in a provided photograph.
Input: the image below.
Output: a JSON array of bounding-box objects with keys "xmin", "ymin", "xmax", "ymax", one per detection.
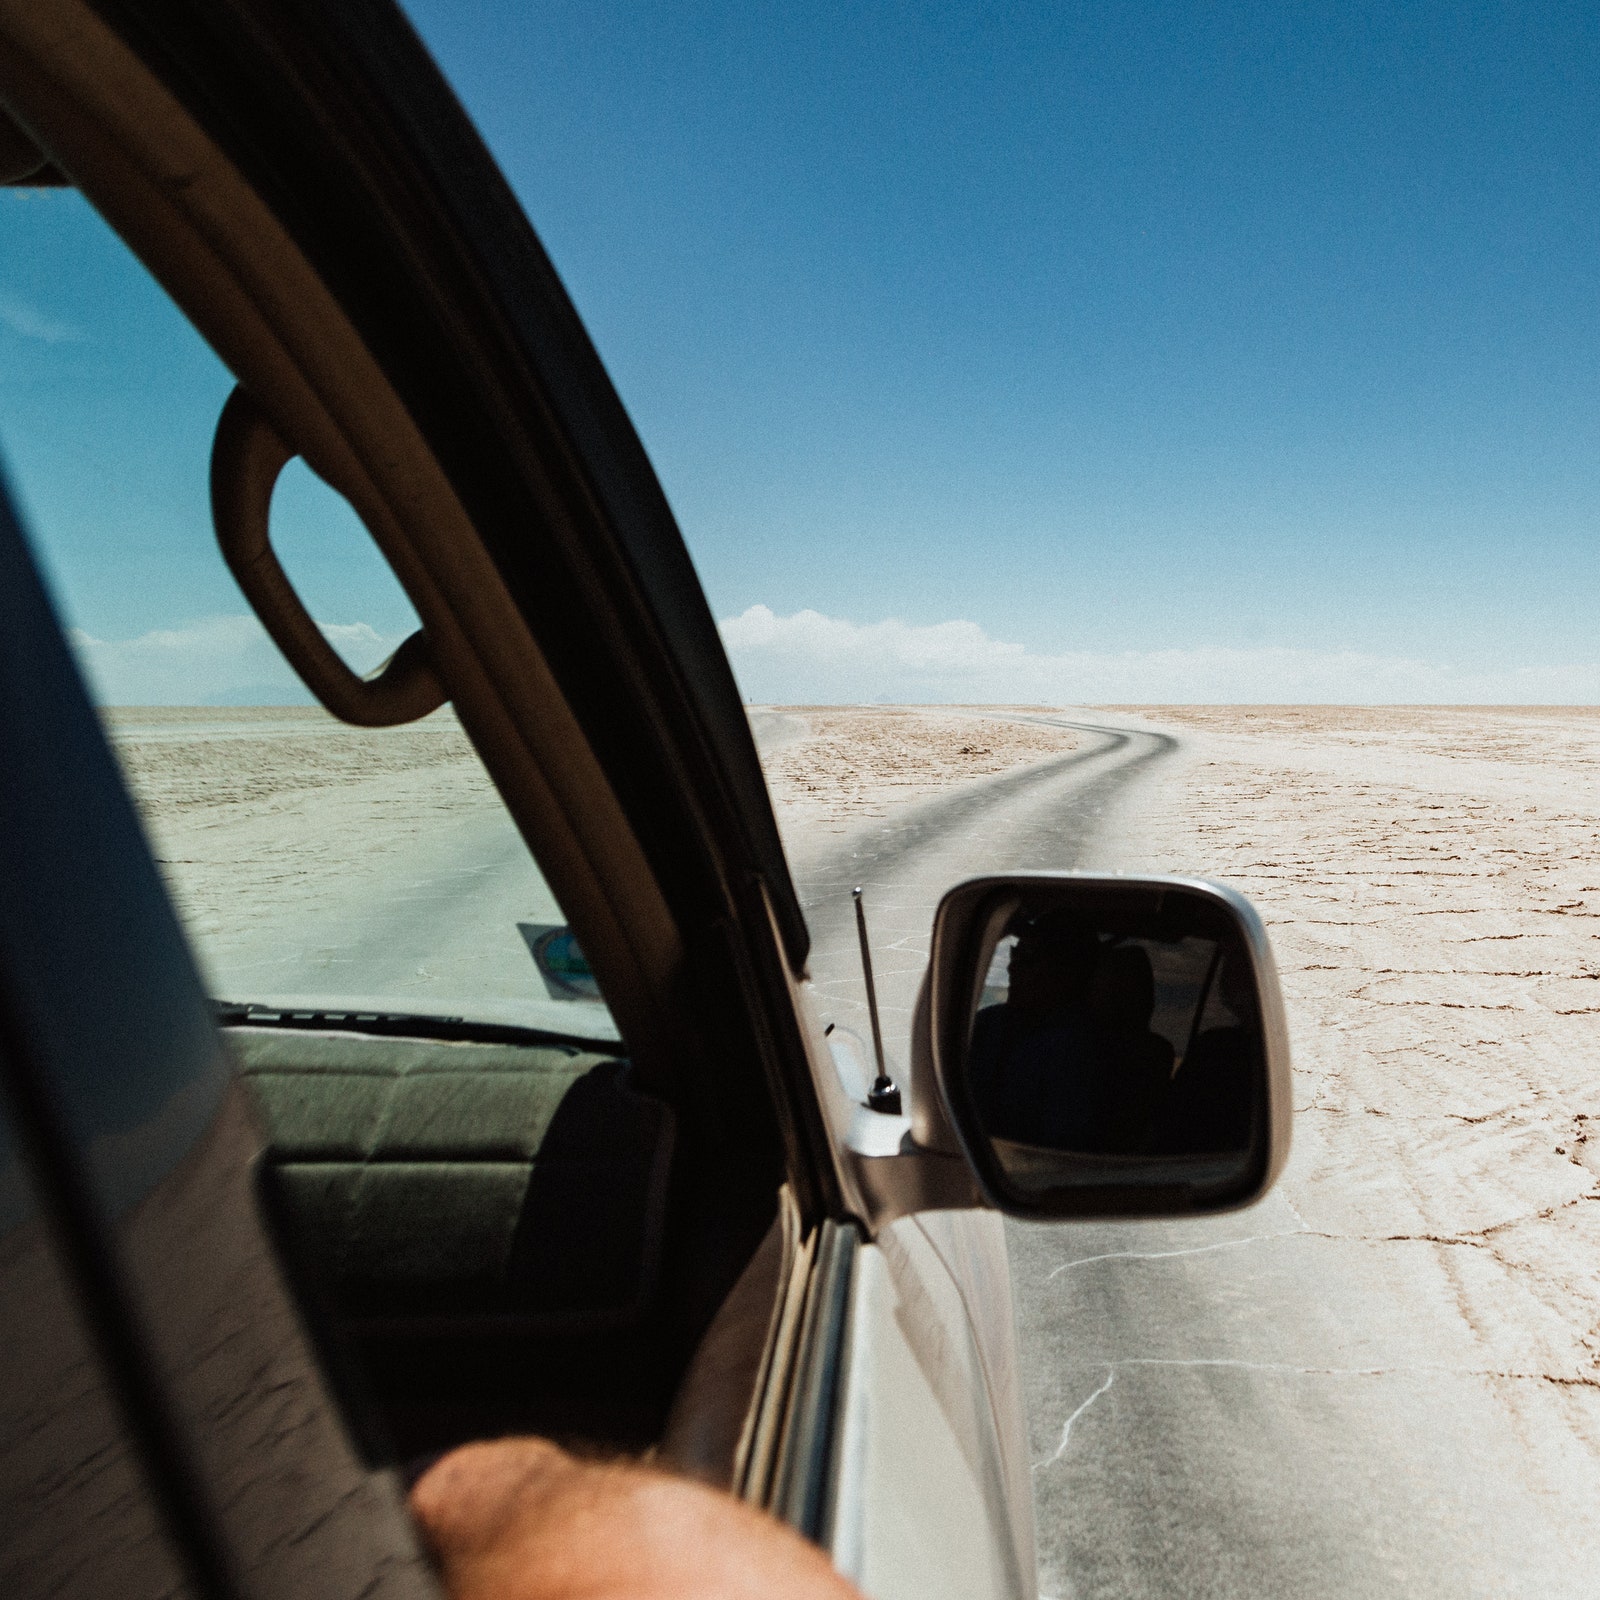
[{"xmin": 1122, "ymin": 707, "xmax": 1600, "ymax": 1401}]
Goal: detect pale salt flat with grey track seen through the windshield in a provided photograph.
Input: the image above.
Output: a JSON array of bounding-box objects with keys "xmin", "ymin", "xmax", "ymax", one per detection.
[{"xmin": 109, "ymin": 707, "xmax": 563, "ymax": 1034}]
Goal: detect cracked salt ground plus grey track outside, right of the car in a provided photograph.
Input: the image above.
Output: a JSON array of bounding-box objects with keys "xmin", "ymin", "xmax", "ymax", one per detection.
[{"xmin": 758, "ymin": 707, "xmax": 1600, "ymax": 1600}]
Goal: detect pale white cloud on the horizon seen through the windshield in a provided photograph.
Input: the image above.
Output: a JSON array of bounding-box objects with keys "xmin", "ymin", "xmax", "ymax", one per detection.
[{"xmin": 69, "ymin": 614, "xmax": 400, "ymax": 706}]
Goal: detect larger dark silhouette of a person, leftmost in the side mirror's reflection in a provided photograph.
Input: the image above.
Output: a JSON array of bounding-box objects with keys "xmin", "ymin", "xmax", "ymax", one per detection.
[{"xmin": 968, "ymin": 912, "xmax": 1101, "ymax": 1150}]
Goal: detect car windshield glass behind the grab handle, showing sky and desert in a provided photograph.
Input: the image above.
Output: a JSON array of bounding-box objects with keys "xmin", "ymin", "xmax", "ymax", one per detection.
[{"xmin": 0, "ymin": 190, "xmax": 618, "ymax": 1040}]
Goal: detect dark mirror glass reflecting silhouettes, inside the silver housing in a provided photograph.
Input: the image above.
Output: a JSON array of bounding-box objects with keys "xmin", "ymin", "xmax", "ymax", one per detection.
[{"xmin": 963, "ymin": 883, "xmax": 1266, "ymax": 1195}]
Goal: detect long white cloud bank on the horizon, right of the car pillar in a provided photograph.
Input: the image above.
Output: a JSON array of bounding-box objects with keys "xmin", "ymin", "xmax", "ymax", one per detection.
[{"xmin": 718, "ymin": 605, "xmax": 1600, "ymax": 706}]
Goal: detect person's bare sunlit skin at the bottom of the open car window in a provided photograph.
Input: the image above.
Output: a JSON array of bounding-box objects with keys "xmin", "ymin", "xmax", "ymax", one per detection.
[{"xmin": 411, "ymin": 1438, "xmax": 861, "ymax": 1600}]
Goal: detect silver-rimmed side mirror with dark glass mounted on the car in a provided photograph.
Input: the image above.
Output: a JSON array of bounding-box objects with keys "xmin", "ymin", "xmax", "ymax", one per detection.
[{"xmin": 914, "ymin": 874, "xmax": 1291, "ymax": 1218}]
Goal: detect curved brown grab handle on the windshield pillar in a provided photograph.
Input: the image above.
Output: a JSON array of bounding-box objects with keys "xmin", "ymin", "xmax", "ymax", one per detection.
[{"xmin": 211, "ymin": 386, "xmax": 445, "ymax": 728}]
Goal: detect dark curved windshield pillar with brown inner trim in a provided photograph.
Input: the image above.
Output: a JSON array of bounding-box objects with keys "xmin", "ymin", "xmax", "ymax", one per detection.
[{"xmin": 0, "ymin": 0, "xmax": 843, "ymax": 1216}]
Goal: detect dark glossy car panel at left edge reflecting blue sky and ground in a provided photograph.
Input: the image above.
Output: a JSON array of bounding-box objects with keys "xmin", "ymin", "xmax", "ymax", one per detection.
[{"xmin": 0, "ymin": 438, "xmax": 434, "ymax": 1597}]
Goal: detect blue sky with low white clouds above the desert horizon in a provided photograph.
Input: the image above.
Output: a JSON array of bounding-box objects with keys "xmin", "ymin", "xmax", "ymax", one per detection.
[{"xmin": 0, "ymin": 0, "xmax": 1600, "ymax": 701}]
